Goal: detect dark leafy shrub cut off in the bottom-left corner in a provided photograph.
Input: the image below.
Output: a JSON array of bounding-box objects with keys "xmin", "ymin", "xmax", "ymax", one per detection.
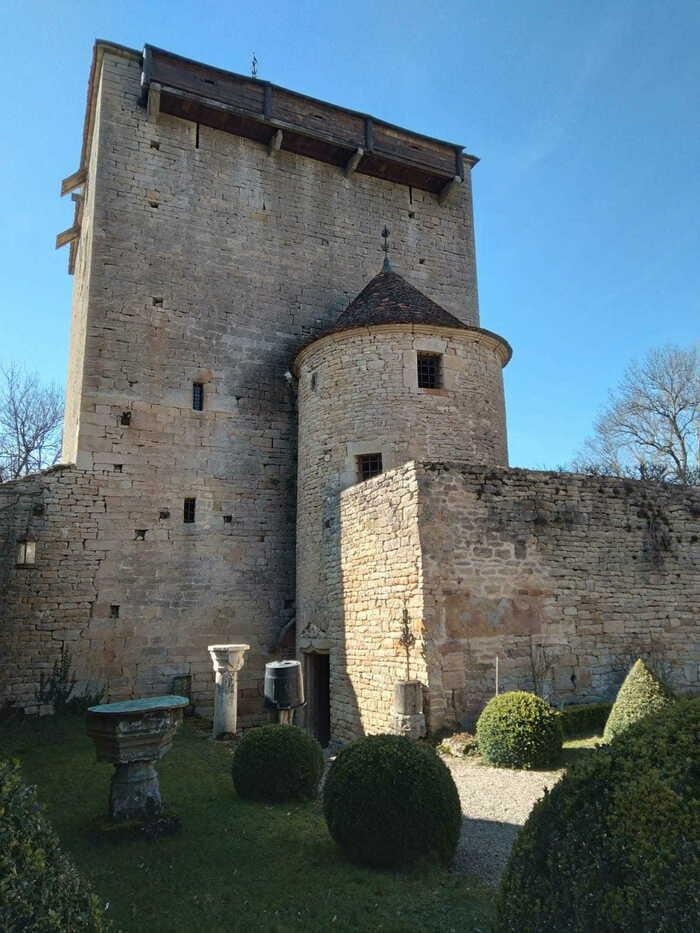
[{"xmin": 0, "ymin": 761, "xmax": 111, "ymax": 933}]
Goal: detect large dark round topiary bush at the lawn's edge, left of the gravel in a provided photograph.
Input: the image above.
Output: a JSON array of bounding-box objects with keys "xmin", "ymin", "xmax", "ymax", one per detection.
[{"xmin": 323, "ymin": 735, "xmax": 462, "ymax": 867}]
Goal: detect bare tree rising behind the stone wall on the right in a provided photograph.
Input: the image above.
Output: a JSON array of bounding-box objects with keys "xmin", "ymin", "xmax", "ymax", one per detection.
[{"xmin": 572, "ymin": 347, "xmax": 700, "ymax": 485}]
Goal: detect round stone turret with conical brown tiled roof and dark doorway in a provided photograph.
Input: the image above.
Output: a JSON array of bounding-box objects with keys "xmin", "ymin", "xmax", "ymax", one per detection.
[{"xmin": 294, "ymin": 261, "xmax": 511, "ymax": 738}]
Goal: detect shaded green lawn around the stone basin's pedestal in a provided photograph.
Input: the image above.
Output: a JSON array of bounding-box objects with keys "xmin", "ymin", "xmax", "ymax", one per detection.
[{"xmin": 0, "ymin": 717, "xmax": 493, "ymax": 933}]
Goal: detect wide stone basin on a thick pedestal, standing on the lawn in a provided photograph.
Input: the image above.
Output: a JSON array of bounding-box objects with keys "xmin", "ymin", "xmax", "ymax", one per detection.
[{"xmin": 86, "ymin": 696, "xmax": 189, "ymax": 820}]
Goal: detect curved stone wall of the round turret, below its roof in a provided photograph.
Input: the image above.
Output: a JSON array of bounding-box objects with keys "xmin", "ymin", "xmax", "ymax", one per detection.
[{"xmin": 297, "ymin": 325, "xmax": 507, "ymax": 660}]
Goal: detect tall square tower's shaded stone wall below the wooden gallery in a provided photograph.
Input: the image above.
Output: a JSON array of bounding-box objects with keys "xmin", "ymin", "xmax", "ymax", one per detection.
[{"xmin": 0, "ymin": 46, "xmax": 478, "ymax": 722}]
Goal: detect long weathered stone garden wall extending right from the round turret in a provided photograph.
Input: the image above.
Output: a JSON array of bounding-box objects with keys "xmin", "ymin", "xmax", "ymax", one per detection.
[{"xmin": 337, "ymin": 463, "xmax": 700, "ymax": 729}]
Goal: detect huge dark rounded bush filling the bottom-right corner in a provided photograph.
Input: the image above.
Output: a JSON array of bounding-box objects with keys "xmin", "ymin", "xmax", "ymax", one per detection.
[{"xmin": 497, "ymin": 698, "xmax": 700, "ymax": 933}]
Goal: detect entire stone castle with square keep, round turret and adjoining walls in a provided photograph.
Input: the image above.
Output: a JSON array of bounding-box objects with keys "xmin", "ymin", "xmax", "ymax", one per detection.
[{"xmin": 0, "ymin": 41, "xmax": 700, "ymax": 741}]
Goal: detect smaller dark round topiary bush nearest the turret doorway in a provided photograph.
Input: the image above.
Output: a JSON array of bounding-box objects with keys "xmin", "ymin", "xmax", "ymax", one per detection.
[{"xmin": 231, "ymin": 725, "xmax": 323, "ymax": 803}]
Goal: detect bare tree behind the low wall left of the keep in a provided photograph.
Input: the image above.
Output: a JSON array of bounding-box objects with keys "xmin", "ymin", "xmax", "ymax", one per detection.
[{"xmin": 0, "ymin": 363, "xmax": 63, "ymax": 482}]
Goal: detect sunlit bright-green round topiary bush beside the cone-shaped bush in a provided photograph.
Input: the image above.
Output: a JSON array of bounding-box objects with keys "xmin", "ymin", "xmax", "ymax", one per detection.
[{"xmin": 476, "ymin": 690, "xmax": 562, "ymax": 768}]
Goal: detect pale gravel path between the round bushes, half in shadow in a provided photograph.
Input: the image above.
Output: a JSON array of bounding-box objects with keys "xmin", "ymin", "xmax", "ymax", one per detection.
[{"xmin": 443, "ymin": 755, "xmax": 563, "ymax": 884}]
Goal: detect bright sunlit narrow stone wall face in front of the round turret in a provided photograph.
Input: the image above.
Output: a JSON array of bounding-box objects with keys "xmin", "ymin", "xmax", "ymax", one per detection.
[{"xmin": 324, "ymin": 464, "xmax": 427, "ymax": 740}]
